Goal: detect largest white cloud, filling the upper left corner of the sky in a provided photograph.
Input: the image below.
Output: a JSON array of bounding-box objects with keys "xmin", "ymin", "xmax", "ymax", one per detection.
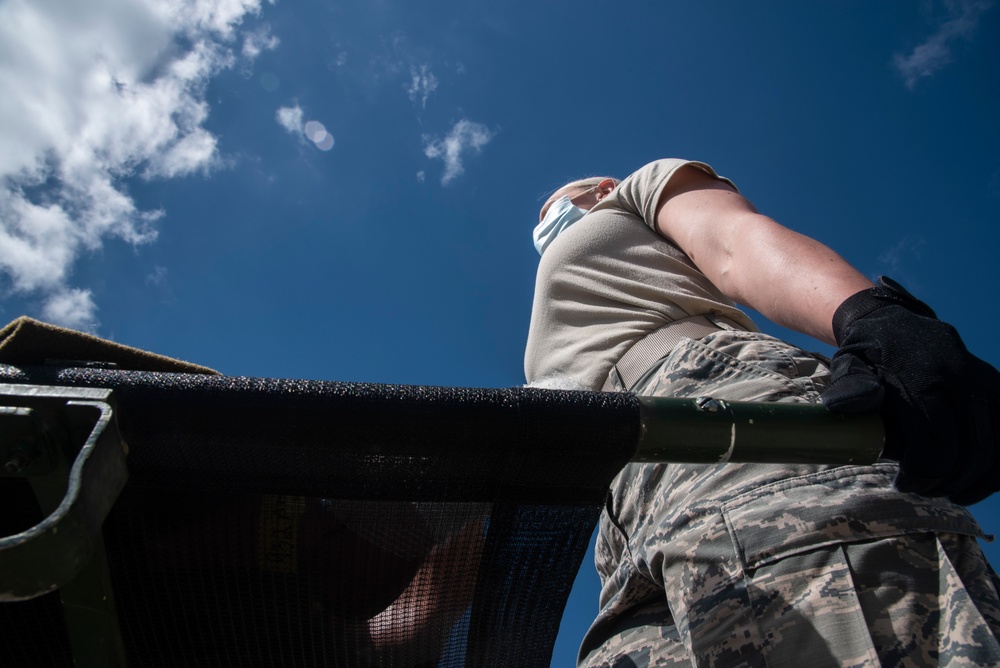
[{"xmin": 0, "ymin": 0, "xmax": 275, "ymax": 328}]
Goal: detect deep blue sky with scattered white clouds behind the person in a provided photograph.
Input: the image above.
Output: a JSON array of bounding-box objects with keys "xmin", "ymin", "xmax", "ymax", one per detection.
[{"xmin": 0, "ymin": 0, "xmax": 1000, "ymax": 666}]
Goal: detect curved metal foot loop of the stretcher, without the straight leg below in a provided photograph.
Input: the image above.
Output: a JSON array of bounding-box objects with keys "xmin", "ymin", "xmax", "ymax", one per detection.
[{"xmin": 0, "ymin": 384, "xmax": 128, "ymax": 601}]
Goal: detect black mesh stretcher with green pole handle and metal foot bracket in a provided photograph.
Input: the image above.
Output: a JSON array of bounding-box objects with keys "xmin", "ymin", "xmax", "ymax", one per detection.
[{"xmin": 0, "ymin": 320, "xmax": 881, "ymax": 667}]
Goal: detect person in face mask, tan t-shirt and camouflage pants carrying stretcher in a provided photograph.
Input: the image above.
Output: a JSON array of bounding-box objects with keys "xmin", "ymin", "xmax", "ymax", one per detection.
[{"xmin": 525, "ymin": 159, "xmax": 1000, "ymax": 667}]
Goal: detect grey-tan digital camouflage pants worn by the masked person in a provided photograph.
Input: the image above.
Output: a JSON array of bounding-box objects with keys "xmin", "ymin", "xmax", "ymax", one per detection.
[{"xmin": 580, "ymin": 331, "xmax": 1000, "ymax": 668}]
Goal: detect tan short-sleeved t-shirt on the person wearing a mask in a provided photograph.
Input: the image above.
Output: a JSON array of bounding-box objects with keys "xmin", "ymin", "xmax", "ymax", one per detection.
[{"xmin": 524, "ymin": 159, "xmax": 757, "ymax": 390}]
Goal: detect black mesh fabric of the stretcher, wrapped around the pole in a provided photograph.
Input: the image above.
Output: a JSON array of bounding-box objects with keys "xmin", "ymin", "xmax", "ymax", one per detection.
[{"xmin": 0, "ymin": 366, "xmax": 639, "ymax": 668}]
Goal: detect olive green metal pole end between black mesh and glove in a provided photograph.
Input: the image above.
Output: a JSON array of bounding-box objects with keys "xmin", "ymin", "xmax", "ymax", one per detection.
[{"xmin": 632, "ymin": 397, "xmax": 884, "ymax": 464}]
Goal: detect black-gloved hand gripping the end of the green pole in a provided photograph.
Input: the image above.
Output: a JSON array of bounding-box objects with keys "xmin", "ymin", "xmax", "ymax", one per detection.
[{"xmin": 822, "ymin": 277, "xmax": 1000, "ymax": 505}]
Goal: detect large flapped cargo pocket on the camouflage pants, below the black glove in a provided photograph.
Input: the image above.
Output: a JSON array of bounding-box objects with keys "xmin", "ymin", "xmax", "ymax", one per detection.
[{"xmin": 722, "ymin": 465, "xmax": 1000, "ymax": 667}]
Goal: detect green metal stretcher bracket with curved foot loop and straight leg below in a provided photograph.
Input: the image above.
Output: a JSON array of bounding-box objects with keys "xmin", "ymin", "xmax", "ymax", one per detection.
[{"xmin": 0, "ymin": 384, "xmax": 128, "ymax": 668}]
